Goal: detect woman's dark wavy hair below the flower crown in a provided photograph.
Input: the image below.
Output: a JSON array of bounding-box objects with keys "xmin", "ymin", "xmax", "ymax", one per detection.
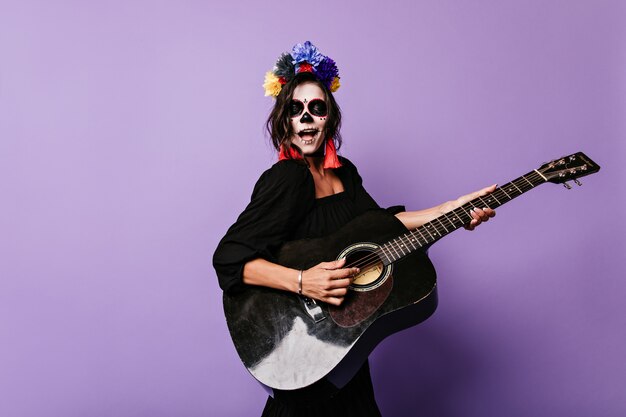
[{"xmin": 265, "ymin": 72, "xmax": 341, "ymax": 157}]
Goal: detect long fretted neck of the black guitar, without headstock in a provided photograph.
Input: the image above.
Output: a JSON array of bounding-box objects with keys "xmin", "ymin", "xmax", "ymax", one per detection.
[{"xmin": 380, "ymin": 170, "xmax": 547, "ymax": 265}]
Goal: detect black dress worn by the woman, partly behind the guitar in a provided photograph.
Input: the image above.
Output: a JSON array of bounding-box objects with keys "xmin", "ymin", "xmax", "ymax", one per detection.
[{"xmin": 213, "ymin": 157, "xmax": 403, "ymax": 417}]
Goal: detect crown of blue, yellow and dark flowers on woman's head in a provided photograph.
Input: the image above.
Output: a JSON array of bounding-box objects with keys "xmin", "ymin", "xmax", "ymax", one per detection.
[{"xmin": 263, "ymin": 41, "xmax": 341, "ymax": 97}]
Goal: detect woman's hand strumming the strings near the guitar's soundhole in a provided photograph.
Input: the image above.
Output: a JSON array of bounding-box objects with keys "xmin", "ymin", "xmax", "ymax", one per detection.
[{"xmin": 302, "ymin": 259, "xmax": 359, "ymax": 306}]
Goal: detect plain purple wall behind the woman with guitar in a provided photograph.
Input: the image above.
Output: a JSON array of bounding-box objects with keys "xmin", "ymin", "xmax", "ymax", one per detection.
[{"xmin": 0, "ymin": 0, "xmax": 626, "ymax": 417}]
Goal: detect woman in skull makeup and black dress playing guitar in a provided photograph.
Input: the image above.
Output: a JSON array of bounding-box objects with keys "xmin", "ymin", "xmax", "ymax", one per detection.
[{"xmin": 213, "ymin": 42, "xmax": 495, "ymax": 417}]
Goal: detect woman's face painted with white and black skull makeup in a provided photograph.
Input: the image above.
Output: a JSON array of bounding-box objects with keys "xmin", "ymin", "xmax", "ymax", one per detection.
[{"xmin": 289, "ymin": 83, "xmax": 328, "ymax": 155}]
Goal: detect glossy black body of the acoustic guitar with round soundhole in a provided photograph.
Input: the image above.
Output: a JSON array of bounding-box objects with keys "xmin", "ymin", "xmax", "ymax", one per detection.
[{"xmin": 224, "ymin": 210, "xmax": 437, "ymax": 390}]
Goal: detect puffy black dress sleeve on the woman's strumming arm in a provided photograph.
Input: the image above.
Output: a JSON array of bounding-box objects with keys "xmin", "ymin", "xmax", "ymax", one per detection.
[{"xmin": 213, "ymin": 160, "xmax": 315, "ymax": 291}]
